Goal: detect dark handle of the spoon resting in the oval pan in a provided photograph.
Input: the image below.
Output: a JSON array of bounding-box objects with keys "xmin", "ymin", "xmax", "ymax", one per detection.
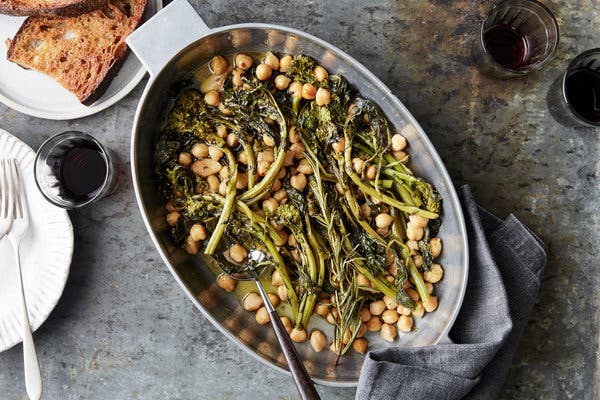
[{"xmin": 256, "ymin": 280, "xmax": 321, "ymax": 400}]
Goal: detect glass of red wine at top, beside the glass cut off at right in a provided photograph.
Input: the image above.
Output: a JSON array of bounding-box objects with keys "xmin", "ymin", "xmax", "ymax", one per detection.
[{"xmin": 474, "ymin": 0, "xmax": 558, "ymax": 78}]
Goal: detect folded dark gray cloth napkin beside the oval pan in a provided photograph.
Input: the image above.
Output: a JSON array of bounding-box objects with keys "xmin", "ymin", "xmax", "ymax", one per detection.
[{"xmin": 356, "ymin": 186, "xmax": 546, "ymax": 400}]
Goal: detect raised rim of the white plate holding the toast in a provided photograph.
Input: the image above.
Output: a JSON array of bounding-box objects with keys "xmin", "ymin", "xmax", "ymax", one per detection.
[{"xmin": 0, "ymin": 0, "xmax": 163, "ymax": 120}]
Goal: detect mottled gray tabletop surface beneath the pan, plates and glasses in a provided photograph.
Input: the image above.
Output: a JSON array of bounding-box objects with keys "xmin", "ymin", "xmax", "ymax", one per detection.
[{"xmin": 0, "ymin": 0, "xmax": 600, "ymax": 400}]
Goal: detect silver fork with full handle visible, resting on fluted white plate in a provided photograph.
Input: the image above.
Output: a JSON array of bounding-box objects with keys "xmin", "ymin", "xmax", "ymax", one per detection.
[{"xmin": 2, "ymin": 160, "xmax": 42, "ymax": 400}]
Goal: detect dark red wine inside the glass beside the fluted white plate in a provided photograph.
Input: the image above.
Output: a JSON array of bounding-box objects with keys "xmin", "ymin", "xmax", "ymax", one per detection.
[{"xmin": 58, "ymin": 144, "xmax": 107, "ymax": 199}]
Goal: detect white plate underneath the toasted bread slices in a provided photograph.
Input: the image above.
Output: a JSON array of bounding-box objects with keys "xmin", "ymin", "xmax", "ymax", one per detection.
[{"xmin": 0, "ymin": 0, "xmax": 162, "ymax": 120}]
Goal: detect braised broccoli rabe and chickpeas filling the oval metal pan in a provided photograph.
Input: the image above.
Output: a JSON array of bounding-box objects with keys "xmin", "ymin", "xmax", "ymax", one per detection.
[{"xmin": 155, "ymin": 53, "xmax": 443, "ymax": 359}]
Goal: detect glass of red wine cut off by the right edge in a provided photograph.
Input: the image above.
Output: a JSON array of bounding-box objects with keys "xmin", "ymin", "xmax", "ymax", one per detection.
[{"xmin": 547, "ymin": 48, "xmax": 600, "ymax": 127}]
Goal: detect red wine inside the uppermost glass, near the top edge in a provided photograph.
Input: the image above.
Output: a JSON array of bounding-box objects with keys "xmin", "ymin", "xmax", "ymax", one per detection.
[{"xmin": 483, "ymin": 24, "xmax": 531, "ymax": 70}]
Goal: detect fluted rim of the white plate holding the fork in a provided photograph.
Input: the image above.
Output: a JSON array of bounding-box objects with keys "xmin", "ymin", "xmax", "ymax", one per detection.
[{"xmin": 0, "ymin": 129, "xmax": 74, "ymax": 353}]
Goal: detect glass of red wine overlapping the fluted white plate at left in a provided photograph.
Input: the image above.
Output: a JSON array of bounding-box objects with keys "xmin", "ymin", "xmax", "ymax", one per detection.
[{"xmin": 34, "ymin": 131, "xmax": 117, "ymax": 209}]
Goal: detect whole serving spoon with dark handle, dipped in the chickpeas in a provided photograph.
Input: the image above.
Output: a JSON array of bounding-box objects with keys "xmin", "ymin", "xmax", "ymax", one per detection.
[{"xmin": 223, "ymin": 250, "xmax": 321, "ymax": 400}]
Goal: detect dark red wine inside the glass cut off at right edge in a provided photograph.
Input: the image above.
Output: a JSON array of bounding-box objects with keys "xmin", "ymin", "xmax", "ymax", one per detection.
[{"xmin": 565, "ymin": 68, "xmax": 600, "ymax": 124}]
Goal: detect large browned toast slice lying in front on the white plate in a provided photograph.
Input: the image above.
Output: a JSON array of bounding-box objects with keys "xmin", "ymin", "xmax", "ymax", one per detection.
[{"xmin": 8, "ymin": 0, "xmax": 147, "ymax": 105}]
